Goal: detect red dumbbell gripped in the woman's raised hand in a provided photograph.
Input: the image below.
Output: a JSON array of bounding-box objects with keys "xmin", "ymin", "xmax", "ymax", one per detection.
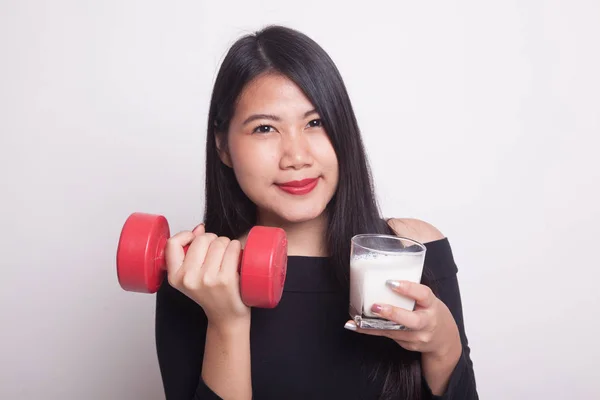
[{"xmin": 117, "ymin": 212, "xmax": 287, "ymax": 308}]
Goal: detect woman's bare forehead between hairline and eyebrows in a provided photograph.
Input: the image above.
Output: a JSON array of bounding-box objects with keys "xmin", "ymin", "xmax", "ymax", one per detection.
[{"xmin": 236, "ymin": 74, "xmax": 314, "ymax": 117}]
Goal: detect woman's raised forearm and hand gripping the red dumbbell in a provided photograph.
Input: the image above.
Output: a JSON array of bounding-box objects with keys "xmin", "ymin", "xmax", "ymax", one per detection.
[{"xmin": 163, "ymin": 225, "xmax": 252, "ymax": 400}]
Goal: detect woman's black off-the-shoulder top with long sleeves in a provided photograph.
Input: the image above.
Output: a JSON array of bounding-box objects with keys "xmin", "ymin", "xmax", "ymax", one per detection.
[{"xmin": 156, "ymin": 238, "xmax": 478, "ymax": 400}]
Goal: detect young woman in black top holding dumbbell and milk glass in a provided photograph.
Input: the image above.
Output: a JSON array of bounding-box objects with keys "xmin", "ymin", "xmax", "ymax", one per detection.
[{"xmin": 156, "ymin": 26, "xmax": 478, "ymax": 400}]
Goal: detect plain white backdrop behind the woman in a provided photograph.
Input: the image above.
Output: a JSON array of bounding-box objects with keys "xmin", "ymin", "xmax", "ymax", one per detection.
[{"xmin": 0, "ymin": 0, "xmax": 600, "ymax": 400}]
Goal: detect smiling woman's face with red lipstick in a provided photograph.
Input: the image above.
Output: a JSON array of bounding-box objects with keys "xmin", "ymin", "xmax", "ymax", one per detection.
[{"xmin": 217, "ymin": 74, "xmax": 338, "ymax": 224}]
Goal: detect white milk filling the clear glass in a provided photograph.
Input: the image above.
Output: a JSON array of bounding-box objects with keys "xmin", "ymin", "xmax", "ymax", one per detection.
[{"xmin": 350, "ymin": 253, "xmax": 424, "ymax": 318}]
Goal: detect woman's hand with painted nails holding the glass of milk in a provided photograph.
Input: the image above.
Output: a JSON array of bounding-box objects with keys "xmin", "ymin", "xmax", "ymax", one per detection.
[{"xmin": 345, "ymin": 281, "xmax": 462, "ymax": 359}]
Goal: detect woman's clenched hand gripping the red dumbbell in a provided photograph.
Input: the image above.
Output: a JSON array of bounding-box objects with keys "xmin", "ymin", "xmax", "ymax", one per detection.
[{"xmin": 165, "ymin": 224, "xmax": 250, "ymax": 328}]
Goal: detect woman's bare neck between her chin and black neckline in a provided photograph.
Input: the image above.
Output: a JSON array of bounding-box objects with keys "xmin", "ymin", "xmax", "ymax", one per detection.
[{"xmin": 240, "ymin": 209, "xmax": 327, "ymax": 257}]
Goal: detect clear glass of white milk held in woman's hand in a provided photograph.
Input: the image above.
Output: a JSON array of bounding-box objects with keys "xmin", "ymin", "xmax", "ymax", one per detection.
[{"xmin": 350, "ymin": 234, "xmax": 426, "ymax": 330}]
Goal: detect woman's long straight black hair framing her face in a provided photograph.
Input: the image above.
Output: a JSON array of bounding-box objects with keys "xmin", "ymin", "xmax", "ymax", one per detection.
[{"xmin": 204, "ymin": 26, "xmax": 428, "ymax": 400}]
